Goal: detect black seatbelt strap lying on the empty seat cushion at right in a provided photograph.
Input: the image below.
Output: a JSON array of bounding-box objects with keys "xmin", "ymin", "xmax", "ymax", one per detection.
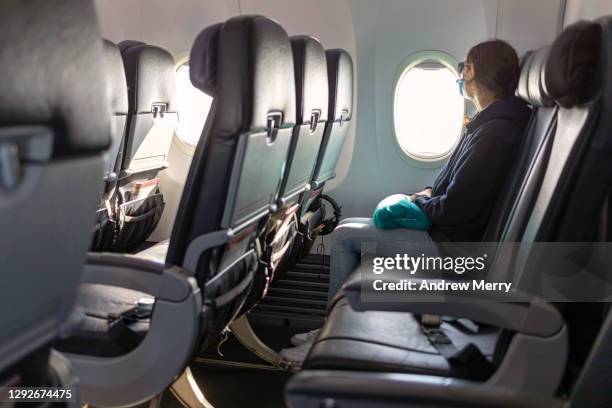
[{"xmin": 421, "ymin": 324, "xmax": 494, "ymax": 381}]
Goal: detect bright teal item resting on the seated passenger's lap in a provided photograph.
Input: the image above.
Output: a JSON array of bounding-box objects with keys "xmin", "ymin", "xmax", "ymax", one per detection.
[{"xmin": 372, "ymin": 194, "xmax": 431, "ymax": 230}]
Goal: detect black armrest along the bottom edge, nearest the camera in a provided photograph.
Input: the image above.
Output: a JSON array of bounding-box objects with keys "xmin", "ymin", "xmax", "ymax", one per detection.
[{"xmin": 285, "ymin": 370, "xmax": 564, "ymax": 408}]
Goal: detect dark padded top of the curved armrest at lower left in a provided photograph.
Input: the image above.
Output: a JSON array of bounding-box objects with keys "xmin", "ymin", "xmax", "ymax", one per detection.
[{"xmin": 81, "ymin": 253, "xmax": 197, "ymax": 302}]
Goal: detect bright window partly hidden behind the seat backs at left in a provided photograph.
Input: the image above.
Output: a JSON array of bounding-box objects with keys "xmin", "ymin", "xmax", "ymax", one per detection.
[{"xmin": 175, "ymin": 64, "xmax": 212, "ymax": 146}]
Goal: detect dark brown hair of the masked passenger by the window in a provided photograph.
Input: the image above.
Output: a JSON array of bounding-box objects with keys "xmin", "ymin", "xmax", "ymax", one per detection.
[{"xmin": 466, "ymin": 40, "xmax": 520, "ymax": 99}]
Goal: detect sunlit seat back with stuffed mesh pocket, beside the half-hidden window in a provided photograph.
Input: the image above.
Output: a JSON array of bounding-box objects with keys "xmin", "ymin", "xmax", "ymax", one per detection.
[{"xmin": 111, "ymin": 41, "xmax": 178, "ymax": 252}]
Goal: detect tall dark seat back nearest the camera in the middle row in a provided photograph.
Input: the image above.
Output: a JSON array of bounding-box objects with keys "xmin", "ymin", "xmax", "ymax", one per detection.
[{"xmin": 166, "ymin": 16, "xmax": 295, "ymax": 344}]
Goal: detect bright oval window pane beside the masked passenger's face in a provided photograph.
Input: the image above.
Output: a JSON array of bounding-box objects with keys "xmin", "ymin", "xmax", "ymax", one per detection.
[{"xmin": 393, "ymin": 55, "xmax": 465, "ymax": 161}]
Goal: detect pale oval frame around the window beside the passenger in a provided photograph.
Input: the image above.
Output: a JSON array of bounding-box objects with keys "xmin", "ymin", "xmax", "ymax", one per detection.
[{"xmin": 391, "ymin": 50, "xmax": 468, "ymax": 168}]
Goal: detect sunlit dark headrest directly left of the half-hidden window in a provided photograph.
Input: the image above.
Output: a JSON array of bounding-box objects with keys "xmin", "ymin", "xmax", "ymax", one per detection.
[{"xmin": 119, "ymin": 40, "xmax": 176, "ymax": 113}]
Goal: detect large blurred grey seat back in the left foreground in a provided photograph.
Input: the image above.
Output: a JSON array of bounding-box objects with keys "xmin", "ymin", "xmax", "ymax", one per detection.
[{"xmin": 0, "ymin": 0, "xmax": 110, "ymax": 386}]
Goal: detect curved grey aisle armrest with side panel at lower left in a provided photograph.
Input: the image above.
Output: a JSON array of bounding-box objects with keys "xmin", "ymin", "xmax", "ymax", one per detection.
[{"xmin": 65, "ymin": 253, "xmax": 202, "ymax": 406}]
